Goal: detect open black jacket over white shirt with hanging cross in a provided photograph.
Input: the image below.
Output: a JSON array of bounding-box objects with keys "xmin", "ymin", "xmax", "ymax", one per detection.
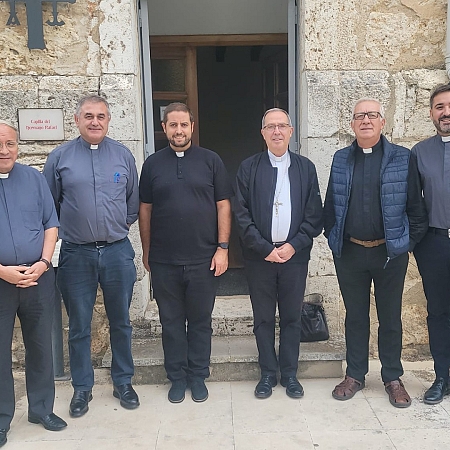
[{"xmin": 234, "ymin": 151, "xmax": 323, "ymax": 263}]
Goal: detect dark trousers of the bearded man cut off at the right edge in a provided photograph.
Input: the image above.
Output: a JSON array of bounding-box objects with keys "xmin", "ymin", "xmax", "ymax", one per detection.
[{"xmin": 414, "ymin": 232, "xmax": 450, "ymax": 379}]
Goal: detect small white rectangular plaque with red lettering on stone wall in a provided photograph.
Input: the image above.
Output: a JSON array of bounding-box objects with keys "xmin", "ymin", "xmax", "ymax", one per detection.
[{"xmin": 19, "ymin": 108, "xmax": 64, "ymax": 141}]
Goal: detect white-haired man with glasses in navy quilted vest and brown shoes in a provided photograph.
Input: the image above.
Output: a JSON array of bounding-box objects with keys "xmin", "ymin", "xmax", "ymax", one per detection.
[{"xmin": 324, "ymin": 98, "xmax": 428, "ymax": 408}]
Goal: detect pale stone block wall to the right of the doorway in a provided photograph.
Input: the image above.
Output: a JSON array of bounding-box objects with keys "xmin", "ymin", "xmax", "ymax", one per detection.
[{"xmin": 299, "ymin": 0, "xmax": 448, "ymax": 357}]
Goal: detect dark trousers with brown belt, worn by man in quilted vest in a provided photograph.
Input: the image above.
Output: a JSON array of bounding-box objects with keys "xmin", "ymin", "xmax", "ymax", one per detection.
[{"xmin": 334, "ymin": 241, "xmax": 408, "ymax": 383}]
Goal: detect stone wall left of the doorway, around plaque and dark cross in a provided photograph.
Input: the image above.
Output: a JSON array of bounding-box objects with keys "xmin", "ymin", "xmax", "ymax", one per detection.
[{"xmin": 0, "ymin": 0, "xmax": 149, "ymax": 359}]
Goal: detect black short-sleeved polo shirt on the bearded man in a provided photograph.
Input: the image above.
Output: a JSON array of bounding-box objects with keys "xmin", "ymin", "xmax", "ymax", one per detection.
[{"xmin": 139, "ymin": 145, "xmax": 233, "ymax": 265}]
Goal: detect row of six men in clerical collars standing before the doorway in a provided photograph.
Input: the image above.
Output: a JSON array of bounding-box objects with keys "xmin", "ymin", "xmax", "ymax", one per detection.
[{"xmin": 0, "ymin": 85, "xmax": 450, "ymax": 446}]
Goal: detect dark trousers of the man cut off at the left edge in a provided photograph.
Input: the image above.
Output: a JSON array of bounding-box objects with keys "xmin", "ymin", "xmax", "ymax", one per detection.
[{"xmin": 0, "ymin": 270, "xmax": 55, "ymax": 430}]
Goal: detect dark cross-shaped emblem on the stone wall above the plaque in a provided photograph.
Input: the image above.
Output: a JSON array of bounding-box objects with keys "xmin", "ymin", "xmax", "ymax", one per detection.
[{"xmin": 0, "ymin": 0, "xmax": 76, "ymax": 49}]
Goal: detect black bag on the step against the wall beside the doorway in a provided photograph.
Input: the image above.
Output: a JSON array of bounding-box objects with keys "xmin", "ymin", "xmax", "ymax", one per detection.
[{"xmin": 300, "ymin": 294, "xmax": 330, "ymax": 342}]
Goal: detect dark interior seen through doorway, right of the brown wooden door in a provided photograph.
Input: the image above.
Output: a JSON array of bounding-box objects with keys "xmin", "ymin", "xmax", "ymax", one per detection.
[{"xmin": 197, "ymin": 45, "xmax": 287, "ymax": 295}]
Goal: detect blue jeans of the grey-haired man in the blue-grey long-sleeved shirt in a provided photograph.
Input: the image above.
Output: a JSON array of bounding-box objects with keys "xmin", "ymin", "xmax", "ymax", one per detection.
[{"xmin": 57, "ymin": 238, "xmax": 136, "ymax": 391}]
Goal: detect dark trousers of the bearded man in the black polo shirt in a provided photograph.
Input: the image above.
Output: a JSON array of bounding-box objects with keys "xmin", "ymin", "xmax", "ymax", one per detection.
[{"xmin": 150, "ymin": 262, "xmax": 219, "ymax": 381}]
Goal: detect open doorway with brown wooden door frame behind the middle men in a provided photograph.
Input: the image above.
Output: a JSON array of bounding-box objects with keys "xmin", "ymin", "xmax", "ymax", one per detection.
[{"xmin": 150, "ymin": 35, "xmax": 288, "ymax": 295}]
